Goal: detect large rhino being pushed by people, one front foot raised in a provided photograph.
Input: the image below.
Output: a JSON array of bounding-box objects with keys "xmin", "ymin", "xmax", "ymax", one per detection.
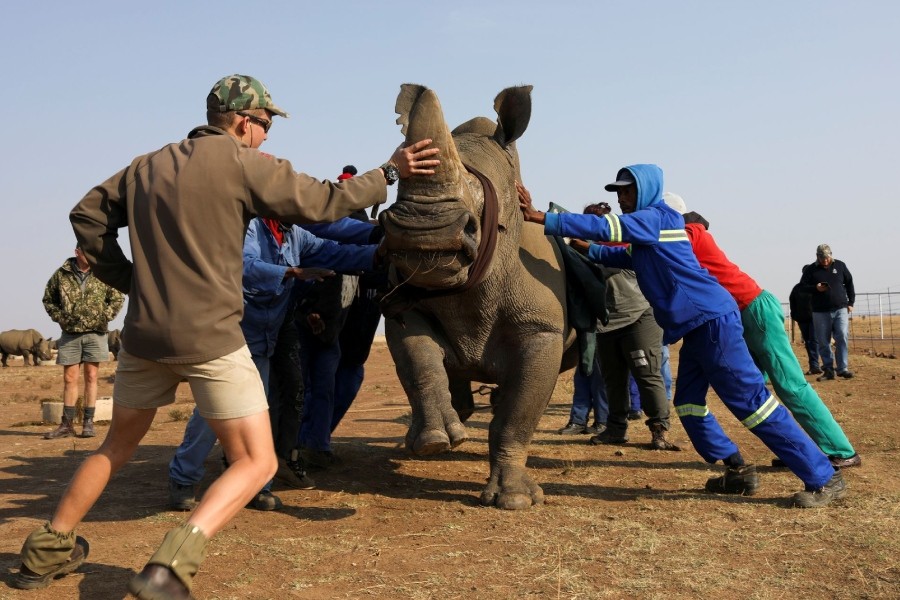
[{"xmin": 379, "ymin": 84, "xmax": 578, "ymax": 510}]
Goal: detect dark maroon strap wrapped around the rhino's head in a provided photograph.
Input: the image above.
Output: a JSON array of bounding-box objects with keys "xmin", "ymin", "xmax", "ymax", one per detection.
[{"xmin": 380, "ymin": 165, "xmax": 500, "ymax": 319}]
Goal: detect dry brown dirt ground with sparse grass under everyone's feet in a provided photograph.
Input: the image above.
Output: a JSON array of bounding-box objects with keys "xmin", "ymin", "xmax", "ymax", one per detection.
[{"xmin": 0, "ymin": 344, "xmax": 900, "ymax": 600}]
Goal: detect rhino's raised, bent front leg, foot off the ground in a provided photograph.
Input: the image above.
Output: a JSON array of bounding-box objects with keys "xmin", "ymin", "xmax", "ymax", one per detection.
[{"xmin": 385, "ymin": 311, "xmax": 468, "ymax": 455}]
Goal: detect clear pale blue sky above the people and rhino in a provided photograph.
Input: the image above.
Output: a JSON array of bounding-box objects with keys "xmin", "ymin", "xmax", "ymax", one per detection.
[{"xmin": 0, "ymin": 0, "xmax": 900, "ymax": 337}]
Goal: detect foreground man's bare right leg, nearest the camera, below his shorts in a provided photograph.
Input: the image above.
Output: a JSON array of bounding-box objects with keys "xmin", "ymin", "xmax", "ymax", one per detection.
[{"xmin": 188, "ymin": 411, "xmax": 278, "ymax": 538}]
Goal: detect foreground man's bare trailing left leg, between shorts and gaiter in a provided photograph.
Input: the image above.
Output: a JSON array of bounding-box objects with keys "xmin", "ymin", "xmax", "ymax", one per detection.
[{"xmin": 50, "ymin": 405, "xmax": 156, "ymax": 532}]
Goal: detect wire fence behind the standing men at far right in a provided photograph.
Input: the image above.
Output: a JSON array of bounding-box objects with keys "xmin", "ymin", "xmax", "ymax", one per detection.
[{"xmin": 781, "ymin": 290, "xmax": 900, "ymax": 356}]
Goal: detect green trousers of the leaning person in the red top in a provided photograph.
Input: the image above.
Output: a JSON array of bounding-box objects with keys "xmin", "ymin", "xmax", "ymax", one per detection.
[{"xmin": 741, "ymin": 290, "xmax": 856, "ymax": 458}]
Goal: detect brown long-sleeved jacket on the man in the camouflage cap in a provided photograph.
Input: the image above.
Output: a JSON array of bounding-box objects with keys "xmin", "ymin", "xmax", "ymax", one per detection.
[{"xmin": 69, "ymin": 126, "xmax": 386, "ymax": 363}]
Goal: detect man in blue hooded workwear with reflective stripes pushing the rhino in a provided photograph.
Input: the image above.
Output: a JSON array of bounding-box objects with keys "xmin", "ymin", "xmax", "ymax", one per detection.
[{"xmin": 519, "ymin": 165, "xmax": 847, "ymax": 508}]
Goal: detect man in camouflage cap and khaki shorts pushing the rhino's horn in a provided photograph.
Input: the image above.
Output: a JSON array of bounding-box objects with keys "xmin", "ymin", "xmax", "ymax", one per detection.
[{"xmin": 12, "ymin": 75, "xmax": 440, "ymax": 599}]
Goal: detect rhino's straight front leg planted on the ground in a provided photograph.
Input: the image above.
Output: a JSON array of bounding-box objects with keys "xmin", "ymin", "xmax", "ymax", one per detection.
[{"xmin": 481, "ymin": 334, "xmax": 562, "ymax": 510}]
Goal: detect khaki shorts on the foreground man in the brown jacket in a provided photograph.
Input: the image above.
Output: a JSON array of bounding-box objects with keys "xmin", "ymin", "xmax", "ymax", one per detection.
[{"xmin": 113, "ymin": 346, "xmax": 269, "ymax": 419}]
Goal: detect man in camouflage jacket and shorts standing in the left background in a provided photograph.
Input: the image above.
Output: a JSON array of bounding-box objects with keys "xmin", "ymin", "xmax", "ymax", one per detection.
[{"xmin": 44, "ymin": 247, "xmax": 125, "ymax": 440}]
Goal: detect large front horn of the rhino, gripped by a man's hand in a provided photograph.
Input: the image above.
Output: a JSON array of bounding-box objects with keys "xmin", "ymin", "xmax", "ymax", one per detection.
[{"xmin": 395, "ymin": 83, "xmax": 464, "ymax": 198}]
